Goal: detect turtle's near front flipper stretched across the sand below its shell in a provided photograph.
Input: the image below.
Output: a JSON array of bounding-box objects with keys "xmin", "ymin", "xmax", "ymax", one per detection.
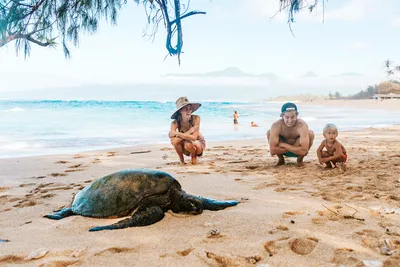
[{"xmin": 89, "ymin": 206, "xmax": 164, "ymax": 232}]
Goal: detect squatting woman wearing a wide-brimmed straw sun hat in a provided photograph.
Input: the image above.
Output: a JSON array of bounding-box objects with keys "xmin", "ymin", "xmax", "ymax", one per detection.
[{"xmin": 169, "ymin": 97, "xmax": 206, "ymax": 165}]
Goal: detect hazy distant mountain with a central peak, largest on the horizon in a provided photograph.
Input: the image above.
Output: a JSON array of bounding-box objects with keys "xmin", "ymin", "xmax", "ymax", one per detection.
[{"xmin": 166, "ymin": 67, "xmax": 279, "ymax": 81}]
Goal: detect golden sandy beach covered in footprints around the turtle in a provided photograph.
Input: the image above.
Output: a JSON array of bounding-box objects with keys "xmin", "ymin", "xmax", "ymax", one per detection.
[{"xmin": 0, "ymin": 100, "xmax": 400, "ymax": 267}]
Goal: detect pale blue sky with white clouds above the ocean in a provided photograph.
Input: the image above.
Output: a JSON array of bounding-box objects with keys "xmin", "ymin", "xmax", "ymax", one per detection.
[{"xmin": 0, "ymin": 0, "xmax": 400, "ymax": 99}]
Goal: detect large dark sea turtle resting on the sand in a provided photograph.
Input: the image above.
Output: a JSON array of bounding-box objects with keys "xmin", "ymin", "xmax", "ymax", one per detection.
[{"xmin": 44, "ymin": 169, "xmax": 239, "ymax": 231}]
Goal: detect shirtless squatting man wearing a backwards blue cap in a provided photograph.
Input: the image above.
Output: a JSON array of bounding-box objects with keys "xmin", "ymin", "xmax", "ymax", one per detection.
[{"xmin": 267, "ymin": 102, "xmax": 314, "ymax": 166}]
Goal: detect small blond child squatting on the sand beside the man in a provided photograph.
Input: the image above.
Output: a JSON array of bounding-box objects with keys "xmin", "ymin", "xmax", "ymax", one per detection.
[{"xmin": 317, "ymin": 123, "xmax": 347, "ymax": 168}]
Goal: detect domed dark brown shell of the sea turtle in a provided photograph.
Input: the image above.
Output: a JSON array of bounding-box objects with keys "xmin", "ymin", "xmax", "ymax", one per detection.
[{"xmin": 72, "ymin": 170, "xmax": 181, "ymax": 218}]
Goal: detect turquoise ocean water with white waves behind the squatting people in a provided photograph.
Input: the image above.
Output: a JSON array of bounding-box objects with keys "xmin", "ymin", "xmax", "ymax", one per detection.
[{"xmin": 0, "ymin": 100, "xmax": 400, "ymax": 158}]
